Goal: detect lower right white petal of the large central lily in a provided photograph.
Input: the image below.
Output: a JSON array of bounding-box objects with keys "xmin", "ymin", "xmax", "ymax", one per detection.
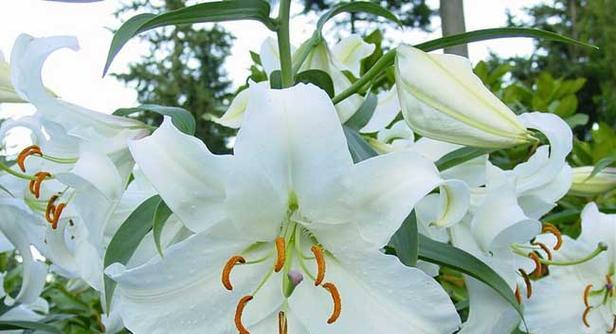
[{"xmin": 289, "ymin": 249, "xmax": 460, "ymax": 333}]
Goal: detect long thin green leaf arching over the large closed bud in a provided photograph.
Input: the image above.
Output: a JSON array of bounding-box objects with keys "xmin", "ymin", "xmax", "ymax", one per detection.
[{"xmin": 415, "ymin": 27, "xmax": 598, "ymax": 51}]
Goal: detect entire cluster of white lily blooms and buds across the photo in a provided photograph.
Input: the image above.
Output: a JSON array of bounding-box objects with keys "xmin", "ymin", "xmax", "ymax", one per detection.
[{"xmin": 0, "ymin": 26, "xmax": 616, "ymax": 334}]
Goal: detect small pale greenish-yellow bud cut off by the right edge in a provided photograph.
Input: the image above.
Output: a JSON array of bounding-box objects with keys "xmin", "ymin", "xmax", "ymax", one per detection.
[{"xmin": 569, "ymin": 166, "xmax": 616, "ymax": 196}]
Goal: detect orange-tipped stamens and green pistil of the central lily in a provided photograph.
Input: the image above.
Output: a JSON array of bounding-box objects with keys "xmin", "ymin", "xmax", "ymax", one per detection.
[{"xmin": 221, "ymin": 207, "xmax": 342, "ymax": 334}]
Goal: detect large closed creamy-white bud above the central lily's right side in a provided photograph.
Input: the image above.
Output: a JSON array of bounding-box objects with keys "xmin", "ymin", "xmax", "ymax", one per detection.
[{"xmin": 396, "ymin": 45, "xmax": 534, "ymax": 148}]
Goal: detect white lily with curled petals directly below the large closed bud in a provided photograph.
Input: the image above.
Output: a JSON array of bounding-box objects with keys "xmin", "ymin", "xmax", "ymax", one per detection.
[{"xmin": 411, "ymin": 113, "xmax": 572, "ymax": 334}]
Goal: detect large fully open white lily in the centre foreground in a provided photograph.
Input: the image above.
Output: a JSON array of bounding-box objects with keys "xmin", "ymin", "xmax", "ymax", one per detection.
[{"xmin": 107, "ymin": 84, "xmax": 459, "ymax": 333}]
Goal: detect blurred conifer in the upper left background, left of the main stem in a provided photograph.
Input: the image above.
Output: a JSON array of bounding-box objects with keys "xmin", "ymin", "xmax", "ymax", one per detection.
[{"xmin": 115, "ymin": 0, "xmax": 233, "ymax": 153}]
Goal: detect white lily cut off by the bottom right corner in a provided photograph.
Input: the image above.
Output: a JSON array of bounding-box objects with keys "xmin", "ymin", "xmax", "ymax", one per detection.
[{"xmin": 524, "ymin": 203, "xmax": 616, "ymax": 334}]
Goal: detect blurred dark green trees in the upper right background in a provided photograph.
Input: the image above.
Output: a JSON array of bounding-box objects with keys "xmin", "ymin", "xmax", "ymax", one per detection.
[{"xmin": 498, "ymin": 0, "xmax": 616, "ymax": 130}]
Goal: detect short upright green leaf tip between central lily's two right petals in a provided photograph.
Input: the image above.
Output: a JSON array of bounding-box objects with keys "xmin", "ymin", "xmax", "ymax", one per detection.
[{"xmin": 389, "ymin": 211, "xmax": 419, "ymax": 267}]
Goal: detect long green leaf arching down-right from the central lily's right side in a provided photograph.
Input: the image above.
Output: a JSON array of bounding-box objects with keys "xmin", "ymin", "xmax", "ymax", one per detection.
[{"xmin": 419, "ymin": 234, "xmax": 524, "ymax": 319}]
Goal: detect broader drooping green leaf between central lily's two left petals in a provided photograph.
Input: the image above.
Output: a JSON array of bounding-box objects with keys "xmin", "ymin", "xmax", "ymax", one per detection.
[{"xmin": 104, "ymin": 195, "xmax": 162, "ymax": 310}]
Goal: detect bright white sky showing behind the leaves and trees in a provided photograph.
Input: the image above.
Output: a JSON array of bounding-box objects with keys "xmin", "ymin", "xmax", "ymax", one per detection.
[{"xmin": 0, "ymin": 0, "xmax": 541, "ymax": 115}]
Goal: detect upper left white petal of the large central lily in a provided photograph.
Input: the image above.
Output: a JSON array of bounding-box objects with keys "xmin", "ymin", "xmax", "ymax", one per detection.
[{"xmin": 129, "ymin": 118, "xmax": 231, "ymax": 232}]
